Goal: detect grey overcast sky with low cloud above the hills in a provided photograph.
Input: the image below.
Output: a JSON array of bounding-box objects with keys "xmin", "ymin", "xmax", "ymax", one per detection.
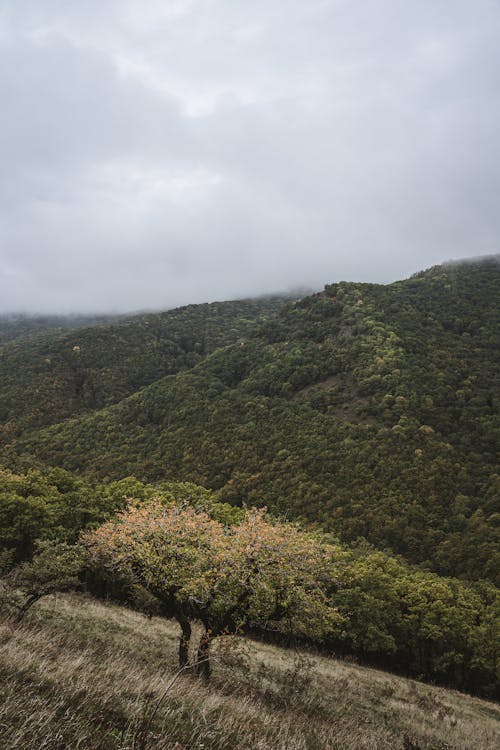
[{"xmin": 0, "ymin": 0, "xmax": 500, "ymax": 312}]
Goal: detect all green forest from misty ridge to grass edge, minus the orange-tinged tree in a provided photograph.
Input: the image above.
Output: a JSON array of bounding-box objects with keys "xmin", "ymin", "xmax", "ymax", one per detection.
[{"xmin": 0, "ymin": 257, "xmax": 500, "ymax": 695}]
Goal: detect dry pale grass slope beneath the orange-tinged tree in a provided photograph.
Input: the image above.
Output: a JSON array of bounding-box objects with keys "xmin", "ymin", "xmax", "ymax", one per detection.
[{"xmin": 0, "ymin": 596, "xmax": 500, "ymax": 750}]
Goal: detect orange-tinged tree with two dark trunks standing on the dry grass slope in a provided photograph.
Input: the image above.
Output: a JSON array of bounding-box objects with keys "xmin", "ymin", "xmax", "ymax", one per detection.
[{"xmin": 82, "ymin": 501, "xmax": 339, "ymax": 677}]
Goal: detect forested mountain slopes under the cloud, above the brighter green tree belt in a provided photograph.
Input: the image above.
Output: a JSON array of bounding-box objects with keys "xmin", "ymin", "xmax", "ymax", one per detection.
[{"xmin": 0, "ymin": 257, "xmax": 500, "ymax": 579}]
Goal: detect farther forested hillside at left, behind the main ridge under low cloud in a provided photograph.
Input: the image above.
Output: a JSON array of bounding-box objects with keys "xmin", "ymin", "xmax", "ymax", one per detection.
[{"xmin": 0, "ymin": 297, "xmax": 286, "ymax": 442}]
